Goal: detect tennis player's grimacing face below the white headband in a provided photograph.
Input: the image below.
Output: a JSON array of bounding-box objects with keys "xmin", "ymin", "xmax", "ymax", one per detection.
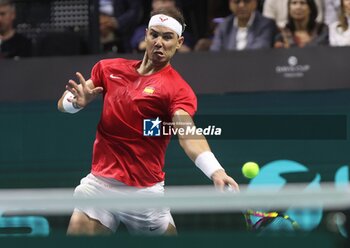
[{"xmin": 145, "ymin": 26, "xmax": 184, "ymax": 64}]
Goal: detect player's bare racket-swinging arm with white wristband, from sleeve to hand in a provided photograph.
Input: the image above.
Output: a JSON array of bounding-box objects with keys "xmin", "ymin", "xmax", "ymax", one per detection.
[{"xmin": 172, "ymin": 109, "xmax": 239, "ymax": 190}]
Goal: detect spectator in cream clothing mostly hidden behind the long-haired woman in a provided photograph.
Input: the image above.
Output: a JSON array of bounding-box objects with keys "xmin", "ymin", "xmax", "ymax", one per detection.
[{"xmin": 263, "ymin": 0, "xmax": 324, "ymax": 28}]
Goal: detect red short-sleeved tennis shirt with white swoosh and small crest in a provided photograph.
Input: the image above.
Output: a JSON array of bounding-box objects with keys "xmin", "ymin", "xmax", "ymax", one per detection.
[{"xmin": 91, "ymin": 59, "xmax": 197, "ymax": 187}]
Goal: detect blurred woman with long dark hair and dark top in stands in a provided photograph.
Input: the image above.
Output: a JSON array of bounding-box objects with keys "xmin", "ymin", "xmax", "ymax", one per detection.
[{"xmin": 275, "ymin": 0, "xmax": 329, "ymax": 48}]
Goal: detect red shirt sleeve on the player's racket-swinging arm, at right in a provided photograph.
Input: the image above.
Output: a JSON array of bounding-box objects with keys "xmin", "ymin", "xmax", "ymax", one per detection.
[{"xmin": 169, "ymin": 85, "xmax": 197, "ymax": 117}]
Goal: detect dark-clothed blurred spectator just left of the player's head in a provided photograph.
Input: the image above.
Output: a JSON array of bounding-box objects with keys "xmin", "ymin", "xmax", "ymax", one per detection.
[{"xmin": 100, "ymin": 0, "xmax": 143, "ymax": 53}]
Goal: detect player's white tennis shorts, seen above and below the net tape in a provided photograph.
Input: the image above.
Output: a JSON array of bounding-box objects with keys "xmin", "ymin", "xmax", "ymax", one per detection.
[{"xmin": 74, "ymin": 173, "xmax": 175, "ymax": 235}]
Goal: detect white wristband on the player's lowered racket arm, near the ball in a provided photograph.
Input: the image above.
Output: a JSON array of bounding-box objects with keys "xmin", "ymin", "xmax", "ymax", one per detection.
[{"xmin": 194, "ymin": 151, "xmax": 224, "ymax": 179}]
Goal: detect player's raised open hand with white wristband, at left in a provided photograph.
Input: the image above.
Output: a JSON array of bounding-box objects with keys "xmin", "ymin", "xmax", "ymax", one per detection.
[{"xmin": 57, "ymin": 72, "xmax": 103, "ymax": 112}]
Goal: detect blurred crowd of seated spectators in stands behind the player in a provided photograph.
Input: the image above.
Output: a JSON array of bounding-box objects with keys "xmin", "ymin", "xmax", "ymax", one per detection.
[{"xmin": 0, "ymin": 0, "xmax": 350, "ymax": 58}]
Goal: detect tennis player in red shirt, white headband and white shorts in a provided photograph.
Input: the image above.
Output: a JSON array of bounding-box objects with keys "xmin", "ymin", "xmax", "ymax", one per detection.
[{"xmin": 58, "ymin": 9, "xmax": 238, "ymax": 235}]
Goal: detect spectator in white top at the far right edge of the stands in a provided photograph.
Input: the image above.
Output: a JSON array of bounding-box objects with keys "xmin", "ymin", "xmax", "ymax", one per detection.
[{"xmin": 329, "ymin": 0, "xmax": 350, "ymax": 46}]
